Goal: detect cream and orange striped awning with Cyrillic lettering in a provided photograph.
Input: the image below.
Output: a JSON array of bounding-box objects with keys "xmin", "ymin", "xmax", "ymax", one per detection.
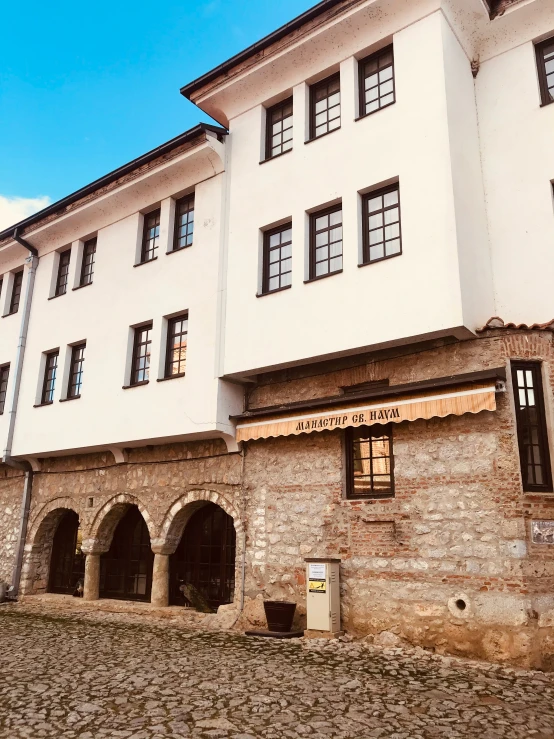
[{"xmin": 237, "ymin": 381, "xmax": 496, "ymax": 441}]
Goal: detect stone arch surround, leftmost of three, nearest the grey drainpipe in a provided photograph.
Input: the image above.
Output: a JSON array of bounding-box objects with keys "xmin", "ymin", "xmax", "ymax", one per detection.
[{"xmin": 20, "ymin": 497, "xmax": 81, "ymax": 595}]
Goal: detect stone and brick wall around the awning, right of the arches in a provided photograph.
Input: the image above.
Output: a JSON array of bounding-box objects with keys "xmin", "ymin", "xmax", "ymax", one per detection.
[{"xmin": 240, "ymin": 332, "xmax": 554, "ymax": 665}]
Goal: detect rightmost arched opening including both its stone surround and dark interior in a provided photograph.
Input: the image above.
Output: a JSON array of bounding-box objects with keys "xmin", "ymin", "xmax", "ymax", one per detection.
[{"xmin": 152, "ymin": 490, "xmax": 244, "ymax": 610}]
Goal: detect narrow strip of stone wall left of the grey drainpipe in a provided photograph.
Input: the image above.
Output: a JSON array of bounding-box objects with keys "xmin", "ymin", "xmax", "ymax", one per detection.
[{"xmin": 0, "ymin": 464, "xmax": 24, "ymax": 584}]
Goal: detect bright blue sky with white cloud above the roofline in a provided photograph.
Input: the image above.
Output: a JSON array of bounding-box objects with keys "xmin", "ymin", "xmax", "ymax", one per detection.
[{"xmin": 0, "ymin": 0, "xmax": 310, "ymax": 228}]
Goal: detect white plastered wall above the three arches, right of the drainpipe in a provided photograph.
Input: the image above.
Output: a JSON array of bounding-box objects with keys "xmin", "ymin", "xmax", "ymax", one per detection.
[{"xmin": 3, "ymin": 158, "xmax": 242, "ymax": 457}]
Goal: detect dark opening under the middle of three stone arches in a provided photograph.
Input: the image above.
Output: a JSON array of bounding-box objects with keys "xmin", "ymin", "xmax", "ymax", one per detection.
[{"xmin": 100, "ymin": 506, "xmax": 154, "ymax": 601}]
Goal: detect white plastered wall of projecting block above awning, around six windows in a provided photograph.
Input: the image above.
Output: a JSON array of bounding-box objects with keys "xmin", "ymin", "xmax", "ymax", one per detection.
[{"xmin": 220, "ymin": 12, "xmax": 484, "ymax": 374}]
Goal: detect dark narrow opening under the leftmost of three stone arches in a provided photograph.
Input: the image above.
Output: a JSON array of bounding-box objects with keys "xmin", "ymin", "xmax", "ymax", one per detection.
[{"xmin": 48, "ymin": 511, "xmax": 85, "ymax": 595}]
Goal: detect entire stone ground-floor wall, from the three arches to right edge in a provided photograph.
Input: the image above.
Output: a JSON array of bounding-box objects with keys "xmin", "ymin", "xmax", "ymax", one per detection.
[{"xmin": 0, "ymin": 331, "xmax": 554, "ymax": 669}]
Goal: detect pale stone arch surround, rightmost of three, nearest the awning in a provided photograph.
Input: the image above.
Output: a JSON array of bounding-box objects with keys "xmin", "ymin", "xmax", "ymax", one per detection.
[{"xmin": 152, "ymin": 490, "xmax": 245, "ymax": 607}]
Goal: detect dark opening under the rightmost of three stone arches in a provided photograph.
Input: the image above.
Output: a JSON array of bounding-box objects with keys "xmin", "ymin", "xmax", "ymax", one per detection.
[{"xmin": 170, "ymin": 503, "xmax": 236, "ymax": 611}]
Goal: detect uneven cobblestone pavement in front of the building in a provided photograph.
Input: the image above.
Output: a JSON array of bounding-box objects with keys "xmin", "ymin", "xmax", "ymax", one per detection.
[{"xmin": 0, "ymin": 605, "xmax": 554, "ymax": 739}]
